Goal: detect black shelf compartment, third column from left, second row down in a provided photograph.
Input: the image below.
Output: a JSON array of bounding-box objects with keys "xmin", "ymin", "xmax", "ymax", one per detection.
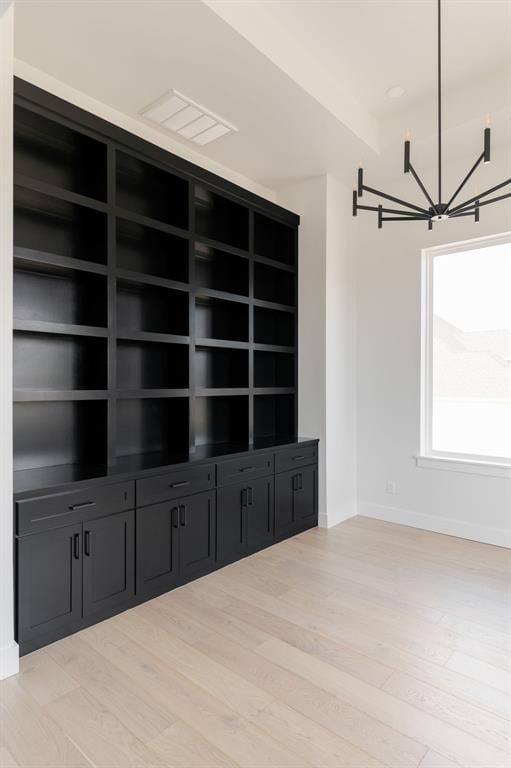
[{"xmin": 195, "ymin": 243, "xmax": 248, "ymax": 296}]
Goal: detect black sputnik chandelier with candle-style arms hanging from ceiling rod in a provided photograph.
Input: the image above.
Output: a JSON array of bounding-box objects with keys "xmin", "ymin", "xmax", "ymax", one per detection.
[{"xmin": 353, "ymin": 0, "xmax": 511, "ymax": 229}]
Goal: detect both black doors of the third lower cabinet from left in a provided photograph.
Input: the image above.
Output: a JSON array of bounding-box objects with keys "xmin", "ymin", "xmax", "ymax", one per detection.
[{"xmin": 217, "ymin": 477, "xmax": 273, "ymax": 564}]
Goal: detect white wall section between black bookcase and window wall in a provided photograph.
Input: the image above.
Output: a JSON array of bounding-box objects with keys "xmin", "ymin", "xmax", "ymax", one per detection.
[{"xmin": 277, "ymin": 176, "xmax": 356, "ymax": 527}]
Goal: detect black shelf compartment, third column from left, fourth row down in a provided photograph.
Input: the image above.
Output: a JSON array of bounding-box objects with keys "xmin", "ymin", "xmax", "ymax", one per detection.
[{"xmin": 194, "ymin": 346, "xmax": 248, "ymax": 389}]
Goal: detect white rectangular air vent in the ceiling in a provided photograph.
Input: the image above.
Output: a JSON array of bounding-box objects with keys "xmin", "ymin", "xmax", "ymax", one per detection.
[{"xmin": 141, "ymin": 91, "xmax": 238, "ymax": 147}]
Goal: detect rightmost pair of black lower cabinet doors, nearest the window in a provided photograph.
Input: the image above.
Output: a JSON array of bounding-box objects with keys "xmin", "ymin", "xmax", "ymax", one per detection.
[{"xmin": 275, "ymin": 465, "xmax": 318, "ymax": 538}]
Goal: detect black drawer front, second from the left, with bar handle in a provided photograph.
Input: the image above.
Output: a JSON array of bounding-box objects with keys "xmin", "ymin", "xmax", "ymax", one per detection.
[{"xmin": 137, "ymin": 464, "xmax": 215, "ymax": 507}]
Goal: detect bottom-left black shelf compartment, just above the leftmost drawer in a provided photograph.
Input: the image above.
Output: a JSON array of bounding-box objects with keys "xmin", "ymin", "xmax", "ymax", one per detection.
[{"xmin": 13, "ymin": 400, "xmax": 107, "ymax": 470}]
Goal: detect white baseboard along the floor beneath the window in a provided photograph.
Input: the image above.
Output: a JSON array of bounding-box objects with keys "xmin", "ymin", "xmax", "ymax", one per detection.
[{"xmin": 358, "ymin": 501, "xmax": 511, "ymax": 549}]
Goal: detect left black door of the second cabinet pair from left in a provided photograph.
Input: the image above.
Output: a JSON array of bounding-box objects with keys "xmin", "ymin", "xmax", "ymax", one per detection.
[{"xmin": 136, "ymin": 501, "xmax": 179, "ymax": 597}]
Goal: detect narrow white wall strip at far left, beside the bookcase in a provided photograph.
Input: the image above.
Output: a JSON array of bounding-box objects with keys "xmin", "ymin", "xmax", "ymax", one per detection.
[{"xmin": 0, "ymin": 0, "xmax": 18, "ymax": 679}]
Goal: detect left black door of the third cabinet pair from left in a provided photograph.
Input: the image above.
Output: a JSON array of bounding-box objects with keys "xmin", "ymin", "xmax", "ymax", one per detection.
[{"xmin": 216, "ymin": 483, "xmax": 248, "ymax": 564}]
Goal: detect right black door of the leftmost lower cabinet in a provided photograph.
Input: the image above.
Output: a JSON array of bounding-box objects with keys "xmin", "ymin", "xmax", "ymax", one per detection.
[{"xmin": 83, "ymin": 511, "xmax": 135, "ymax": 616}]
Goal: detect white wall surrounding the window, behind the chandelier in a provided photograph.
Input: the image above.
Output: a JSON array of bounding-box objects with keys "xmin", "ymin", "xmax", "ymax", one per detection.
[{"xmin": 357, "ymin": 152, "xmax": 511, "ymax": 545}]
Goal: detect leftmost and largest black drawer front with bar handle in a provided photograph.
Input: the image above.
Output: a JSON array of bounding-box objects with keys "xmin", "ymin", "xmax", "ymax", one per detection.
[{"xmin": 17, "ymin": 481, "xmax": 135, "ymax": 536}]
